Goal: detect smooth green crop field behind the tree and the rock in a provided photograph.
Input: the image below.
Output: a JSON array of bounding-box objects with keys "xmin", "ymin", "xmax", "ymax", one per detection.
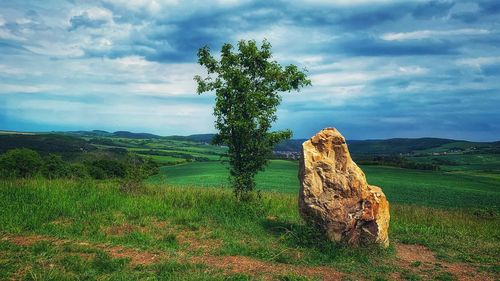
[{"xmin": 150, "ymin": 160, "xmax": 500, "ymax": 211}]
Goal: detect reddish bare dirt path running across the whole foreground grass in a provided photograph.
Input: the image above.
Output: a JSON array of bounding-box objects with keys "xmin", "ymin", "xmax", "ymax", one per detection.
[{"xmin": 0, "ymin": 235, "xmax": 496, "ymax": 281}]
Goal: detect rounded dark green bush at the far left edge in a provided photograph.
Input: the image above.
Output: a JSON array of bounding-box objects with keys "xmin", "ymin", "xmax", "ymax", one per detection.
[{"xmin": 0, "ymin": 148, "xmax": 43, "ymax": 178}]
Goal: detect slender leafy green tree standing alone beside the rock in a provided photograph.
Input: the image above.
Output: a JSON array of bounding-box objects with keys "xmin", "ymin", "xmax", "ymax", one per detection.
[{"xmin": 194, "ymin": 40, "xmax": 311, "ymax": 199}]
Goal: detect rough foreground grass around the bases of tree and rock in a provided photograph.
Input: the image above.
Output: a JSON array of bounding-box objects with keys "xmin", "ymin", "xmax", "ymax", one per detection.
[{"xmin": 0, "ymin": 178, "xmax": 500, "ymax": 280}]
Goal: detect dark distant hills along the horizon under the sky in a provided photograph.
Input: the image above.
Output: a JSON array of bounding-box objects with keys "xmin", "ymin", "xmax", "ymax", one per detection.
[{"xmin": 0, "ymin": 130, "xmax": 500, "ymax": 156}]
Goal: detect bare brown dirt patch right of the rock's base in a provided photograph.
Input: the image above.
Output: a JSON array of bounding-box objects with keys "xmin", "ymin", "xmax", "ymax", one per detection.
[{"xmin": 393, "ymin": 244, "xmax": 496, "ymax": 281}]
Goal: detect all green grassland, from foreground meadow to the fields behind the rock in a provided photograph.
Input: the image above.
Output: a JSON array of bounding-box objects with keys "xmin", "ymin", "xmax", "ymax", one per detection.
[{"xmin": 0, "ymin": 134, "xmax": 500, "ymax": 280}]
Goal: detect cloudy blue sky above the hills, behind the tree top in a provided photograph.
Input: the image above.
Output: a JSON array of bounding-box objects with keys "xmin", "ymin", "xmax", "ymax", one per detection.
[{"xmin": 0, "ymin": 0, "xmax": 500, "ymax": 141}]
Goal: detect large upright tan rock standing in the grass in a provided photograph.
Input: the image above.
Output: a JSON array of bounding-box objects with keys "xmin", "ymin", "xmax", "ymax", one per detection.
[{"xmin": 299, "ymin": 128, "xmax": 389, "ymax": 247}]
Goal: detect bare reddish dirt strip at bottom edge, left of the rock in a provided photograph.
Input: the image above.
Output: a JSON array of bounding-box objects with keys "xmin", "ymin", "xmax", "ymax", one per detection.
[{"xmin": 192, "ymin": 256, "xmax": 343, "ymax": 280}]
